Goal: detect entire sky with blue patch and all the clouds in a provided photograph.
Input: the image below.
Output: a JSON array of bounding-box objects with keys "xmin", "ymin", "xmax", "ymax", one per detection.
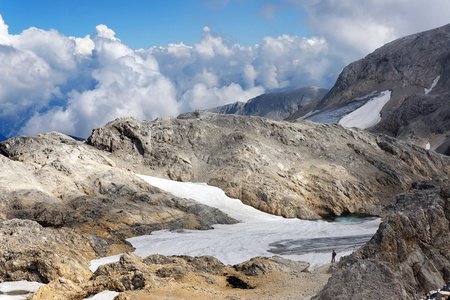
[{"xmin": 0, "ymin": 0, "xmax": 450, "ymax": 138}]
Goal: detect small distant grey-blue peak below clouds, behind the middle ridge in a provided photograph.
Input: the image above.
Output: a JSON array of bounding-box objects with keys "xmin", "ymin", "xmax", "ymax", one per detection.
[{"xmin": 207, "ymin": 86, "xmax": 328, "ymax": 120}]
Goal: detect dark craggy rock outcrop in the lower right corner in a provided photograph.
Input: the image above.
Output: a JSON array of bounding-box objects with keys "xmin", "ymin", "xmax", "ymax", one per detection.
[{"xmin": 317, "ymin": 181, "xmax": 450, "ymax": 299}]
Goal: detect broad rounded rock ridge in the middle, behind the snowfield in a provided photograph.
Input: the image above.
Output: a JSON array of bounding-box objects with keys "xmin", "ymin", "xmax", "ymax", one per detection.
[{"xmin": 87, "ymin": 112, "xmax": 450, "ymax": 219}]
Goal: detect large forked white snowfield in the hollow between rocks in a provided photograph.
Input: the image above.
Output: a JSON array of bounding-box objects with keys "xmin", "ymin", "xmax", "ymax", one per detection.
[{"xmin": 90, "ymin": 175, "xmax": 380, "ymax": 271}]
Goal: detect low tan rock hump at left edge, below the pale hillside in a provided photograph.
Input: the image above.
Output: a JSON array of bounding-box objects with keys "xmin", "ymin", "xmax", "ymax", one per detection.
[{"xmin": 0, "ymin": 219, "xmax": 95, "ymax": 283}]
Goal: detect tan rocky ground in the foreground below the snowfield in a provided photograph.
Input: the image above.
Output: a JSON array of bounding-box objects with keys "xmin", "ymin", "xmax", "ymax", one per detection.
[{"xmin": 30, "ymin": 253, "xmax": 329, "ymax": 300}]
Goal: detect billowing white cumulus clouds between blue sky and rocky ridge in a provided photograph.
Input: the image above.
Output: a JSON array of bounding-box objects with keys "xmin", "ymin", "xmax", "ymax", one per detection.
[{"xmin": 0, "ymin": 19, "xmax": 341, "ymax": 137}]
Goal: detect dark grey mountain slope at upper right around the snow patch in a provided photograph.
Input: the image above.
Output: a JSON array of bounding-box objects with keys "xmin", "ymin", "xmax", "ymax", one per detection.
[{"xmin": 289, "ymin": 25, "xmax": 450, "ymax": 155}]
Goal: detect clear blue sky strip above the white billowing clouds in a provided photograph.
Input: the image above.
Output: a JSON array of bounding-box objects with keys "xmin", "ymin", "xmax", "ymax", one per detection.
[{"xmin": 0, "ymin": 0, "xmax": 310, "ymax": 49}]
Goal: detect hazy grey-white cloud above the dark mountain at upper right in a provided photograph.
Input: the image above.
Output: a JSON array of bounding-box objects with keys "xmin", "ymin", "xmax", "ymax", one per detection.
[{"xmin": 284, "ymin": 0, "xmax": 450, "ymax": 63}]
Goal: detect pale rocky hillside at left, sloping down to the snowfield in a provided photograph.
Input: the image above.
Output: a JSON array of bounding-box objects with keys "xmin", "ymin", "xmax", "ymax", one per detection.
[{"xmin": 0, "ymin": 133, "xmax": 236, "ymax": 283}]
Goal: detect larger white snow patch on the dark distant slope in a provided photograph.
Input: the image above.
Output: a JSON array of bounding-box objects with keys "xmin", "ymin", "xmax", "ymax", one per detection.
[{"xmin": 339, "ymin": 91, "xmax": 391, "ymax": 129}]
